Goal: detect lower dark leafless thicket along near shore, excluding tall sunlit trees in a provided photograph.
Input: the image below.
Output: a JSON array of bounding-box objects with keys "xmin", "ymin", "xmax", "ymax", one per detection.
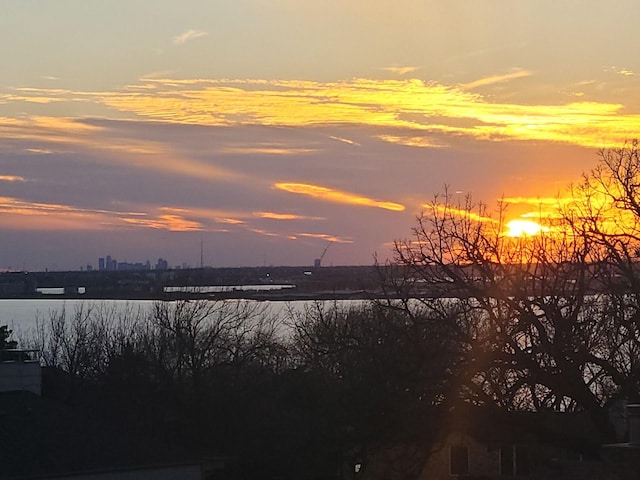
[{"xmin": 21, "ymin": 300, "xmax": 463, "ymax": 478}]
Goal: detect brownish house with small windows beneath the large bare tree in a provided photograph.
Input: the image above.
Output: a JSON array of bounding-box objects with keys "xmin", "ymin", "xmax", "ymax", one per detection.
[{"xmin": 419, "ymin": 407, "xmax": 611, "ymax": 480}]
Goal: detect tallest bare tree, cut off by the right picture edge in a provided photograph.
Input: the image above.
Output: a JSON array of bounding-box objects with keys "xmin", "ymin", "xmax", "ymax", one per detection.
[{"xmin": 563, "ymin": 140, "xmax": 640, "ymax": 400}]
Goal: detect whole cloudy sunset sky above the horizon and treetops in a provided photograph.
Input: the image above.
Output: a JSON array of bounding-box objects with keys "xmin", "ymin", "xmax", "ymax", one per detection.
[{"xmin": 0, "ymin": 0, "xmax": 640, "ymax": 270}]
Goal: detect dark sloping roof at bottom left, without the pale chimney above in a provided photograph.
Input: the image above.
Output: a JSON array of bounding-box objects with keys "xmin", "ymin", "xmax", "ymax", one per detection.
[{"xmin": 0, "ymin": 390, "xmax": 210, "ymax": 480}]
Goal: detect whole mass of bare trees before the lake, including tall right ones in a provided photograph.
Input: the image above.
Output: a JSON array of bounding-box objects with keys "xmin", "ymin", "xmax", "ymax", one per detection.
[{"xmin": 10, "ymin": 143, "xmax": 640, "ymax": 479}]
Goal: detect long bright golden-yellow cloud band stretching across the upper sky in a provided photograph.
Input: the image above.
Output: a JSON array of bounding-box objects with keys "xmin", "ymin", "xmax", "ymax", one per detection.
[{"xmin": 7, "ymin": 77, "xmax": 640, "ymax": 149}]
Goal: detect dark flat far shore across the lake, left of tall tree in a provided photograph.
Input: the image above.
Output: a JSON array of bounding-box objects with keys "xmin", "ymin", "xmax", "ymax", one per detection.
[{"xmin": 0, "ymin": 266, "xmax": 380, "ymax": 301}]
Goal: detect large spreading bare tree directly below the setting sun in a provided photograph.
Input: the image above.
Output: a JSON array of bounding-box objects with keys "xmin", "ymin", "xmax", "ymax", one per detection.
[{"xmin": 384, "ymin": 186, "xmax": 619, "ymax": 435}]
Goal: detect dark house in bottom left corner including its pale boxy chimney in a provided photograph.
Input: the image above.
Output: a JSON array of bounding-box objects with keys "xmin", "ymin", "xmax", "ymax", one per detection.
[{"xmin": 0, "ymin": 350, "xmax": 235, "ymax": 480}]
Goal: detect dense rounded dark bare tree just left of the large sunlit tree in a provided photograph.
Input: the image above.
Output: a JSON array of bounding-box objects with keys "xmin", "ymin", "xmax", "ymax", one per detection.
[{"xmin": 293, "ymin": 302, "xmax": 461, "ymax": 478}]
